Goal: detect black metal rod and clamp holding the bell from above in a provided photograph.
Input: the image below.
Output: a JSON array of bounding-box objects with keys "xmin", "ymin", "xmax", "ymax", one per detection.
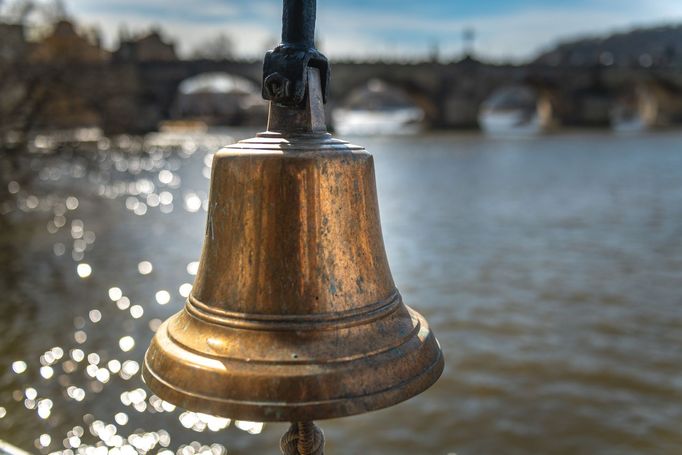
[{"xmin": 263, "ymin": 0, "xmax": 331, "ymax": 108}]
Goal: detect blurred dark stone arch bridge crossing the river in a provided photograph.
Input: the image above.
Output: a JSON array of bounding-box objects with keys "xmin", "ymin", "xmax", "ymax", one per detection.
[{"xmin": 112, "ymin": 58, "xmax": 682, "ymax": 130}]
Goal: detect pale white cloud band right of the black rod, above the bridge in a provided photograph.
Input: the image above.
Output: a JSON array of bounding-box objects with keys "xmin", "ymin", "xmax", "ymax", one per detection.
[{"xmin": 320, "ymin": 0, "xmax": 682, "ymax": 60}]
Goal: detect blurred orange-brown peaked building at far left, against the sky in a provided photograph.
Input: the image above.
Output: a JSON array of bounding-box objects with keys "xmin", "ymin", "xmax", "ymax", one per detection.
[{"xmin": 31, "ymin": 20, "xmax": 110, "ymax": 63}]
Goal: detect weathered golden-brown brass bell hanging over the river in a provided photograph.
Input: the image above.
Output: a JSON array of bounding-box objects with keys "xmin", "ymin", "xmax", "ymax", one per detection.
[{"xmin": 143, "ymin": 133, "xmax": 443, "ymax": 421}]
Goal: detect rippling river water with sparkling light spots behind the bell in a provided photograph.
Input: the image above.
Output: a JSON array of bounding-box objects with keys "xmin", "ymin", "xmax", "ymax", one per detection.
[{"xmin": 0, "ymin": 131, "xmax": 682, "ymax": 455}]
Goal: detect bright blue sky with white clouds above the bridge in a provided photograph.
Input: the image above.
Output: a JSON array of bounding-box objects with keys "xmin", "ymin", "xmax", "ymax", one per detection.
[{"xmin": 65, "ymin": 0, "xmax": 682, "ymax": 61}]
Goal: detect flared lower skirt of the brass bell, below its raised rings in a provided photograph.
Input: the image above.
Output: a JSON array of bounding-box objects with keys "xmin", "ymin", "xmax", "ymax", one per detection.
[{"xmin": 143, "ymin": 294, "xmax": 443, "ymax": 422}]
